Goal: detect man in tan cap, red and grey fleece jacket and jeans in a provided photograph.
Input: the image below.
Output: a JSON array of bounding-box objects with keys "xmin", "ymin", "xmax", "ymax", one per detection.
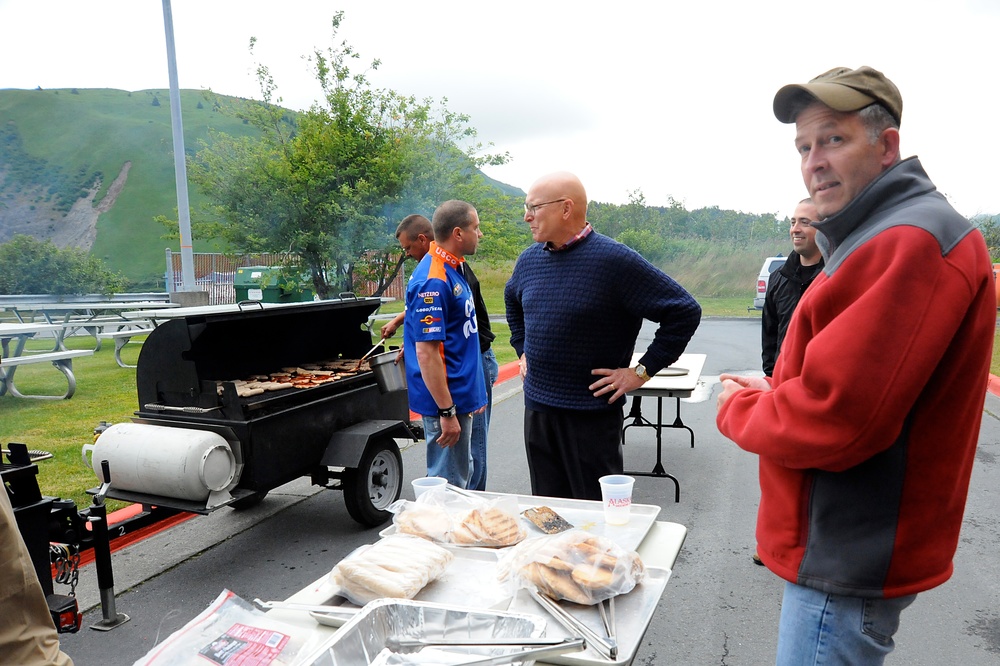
[{"xmin": 716, "ymin": 67, "xmax": 996, "ymax": 666}]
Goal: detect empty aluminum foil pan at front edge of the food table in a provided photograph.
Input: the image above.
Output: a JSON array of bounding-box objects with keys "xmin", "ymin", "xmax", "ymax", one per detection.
[{"xmin": 303, "ymin": 599, "xmax": 546, "ymax": 666}]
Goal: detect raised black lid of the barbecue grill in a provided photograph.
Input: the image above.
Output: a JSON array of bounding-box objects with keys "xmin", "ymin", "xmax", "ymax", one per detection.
[{"xmin": 136, "ymin": 298, "xmax": 380, "ymax": 410}]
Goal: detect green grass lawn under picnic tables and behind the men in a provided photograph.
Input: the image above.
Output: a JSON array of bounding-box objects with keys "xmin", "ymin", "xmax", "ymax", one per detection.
[{"xmin": 0, "ymin": 304, "xmax": 1000, "ymax": 510}]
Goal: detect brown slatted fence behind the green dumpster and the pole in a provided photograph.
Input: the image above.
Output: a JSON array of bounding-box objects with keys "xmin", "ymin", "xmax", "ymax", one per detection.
[{"xmin": 164, "ymin": 248, "xmax": 406, "ymax": 305}]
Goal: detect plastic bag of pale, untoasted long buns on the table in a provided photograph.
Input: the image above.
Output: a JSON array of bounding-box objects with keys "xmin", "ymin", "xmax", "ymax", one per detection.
[{"xmin": 330, "ymin": 534, "xmax": 454, "ymax": 606}]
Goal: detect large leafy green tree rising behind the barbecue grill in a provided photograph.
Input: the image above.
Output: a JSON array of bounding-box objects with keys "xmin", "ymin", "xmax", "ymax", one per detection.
[{"xmin": 191, "ymin": 12, "xmax": 511, "ymax": 298}]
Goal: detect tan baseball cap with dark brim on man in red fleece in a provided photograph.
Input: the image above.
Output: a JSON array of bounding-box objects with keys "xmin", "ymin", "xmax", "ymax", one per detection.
[{"xmin": 774, "ymin": 67, "xmax": 903, "ymax": 123}]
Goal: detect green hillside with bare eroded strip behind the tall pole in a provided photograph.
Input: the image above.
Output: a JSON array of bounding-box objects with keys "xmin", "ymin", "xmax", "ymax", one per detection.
[{"xmin": 0, "ymin": 89, "xmax": 255, "ymax": 287}]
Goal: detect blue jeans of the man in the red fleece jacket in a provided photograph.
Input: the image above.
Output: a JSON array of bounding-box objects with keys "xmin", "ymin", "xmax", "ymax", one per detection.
[{"xmin": 776, "ymin": 582, "xmax": 917, "ymax": 666}]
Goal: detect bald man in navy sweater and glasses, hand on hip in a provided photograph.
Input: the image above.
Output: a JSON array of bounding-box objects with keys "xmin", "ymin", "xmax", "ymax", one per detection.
[{"xmin": 504, "ymin": 173, "xmax": 701, "ymax": 500}]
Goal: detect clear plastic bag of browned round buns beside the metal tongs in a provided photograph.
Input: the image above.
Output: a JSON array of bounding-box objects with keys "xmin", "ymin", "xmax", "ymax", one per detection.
[{"xmin": 499, "ymin": 529, "xmax": 645, "ymax": 605}]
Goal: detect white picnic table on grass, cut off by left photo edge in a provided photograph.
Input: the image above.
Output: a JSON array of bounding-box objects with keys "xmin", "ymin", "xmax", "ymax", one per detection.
[{"xmin": 0, "ymin": 322, "xmax": 94, "ymax": 400}]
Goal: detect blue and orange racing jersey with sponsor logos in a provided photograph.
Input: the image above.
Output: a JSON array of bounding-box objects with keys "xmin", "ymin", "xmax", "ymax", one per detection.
[{"xmin": 403, "ymin": 243, "xmax": 486, "ymax": 416}]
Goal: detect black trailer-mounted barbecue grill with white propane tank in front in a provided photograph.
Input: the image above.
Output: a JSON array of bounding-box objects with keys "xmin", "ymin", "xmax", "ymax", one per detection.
[{"xmin": 84, "ymin": 296, "xmax": 415, "ymax": 526}]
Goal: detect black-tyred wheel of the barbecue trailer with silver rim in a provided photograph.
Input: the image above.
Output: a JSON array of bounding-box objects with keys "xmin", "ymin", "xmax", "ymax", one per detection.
[{"xmin": 344, "ymin": 438, "xmax": 403, "ymax": 527}]
